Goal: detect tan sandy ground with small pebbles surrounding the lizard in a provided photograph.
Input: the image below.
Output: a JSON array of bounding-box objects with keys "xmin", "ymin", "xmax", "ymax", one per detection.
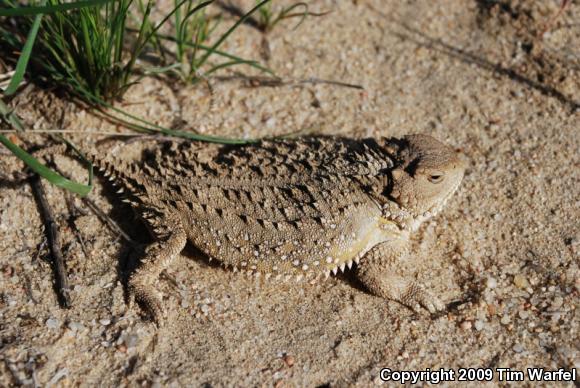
[{"xmin": 0, "ymin": 0, "xmax": 580, "ymax": 387}]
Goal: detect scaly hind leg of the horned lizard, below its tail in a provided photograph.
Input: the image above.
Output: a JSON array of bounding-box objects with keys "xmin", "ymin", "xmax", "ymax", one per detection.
[{"xmin": 129, "ymin": 224, "xmax": 187, "ymax": 326}]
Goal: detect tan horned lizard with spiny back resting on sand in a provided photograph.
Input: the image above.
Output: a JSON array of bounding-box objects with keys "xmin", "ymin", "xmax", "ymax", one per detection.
[{"xmin": 90, "ymin": 134, "xmax": 465, "ymax": 324}]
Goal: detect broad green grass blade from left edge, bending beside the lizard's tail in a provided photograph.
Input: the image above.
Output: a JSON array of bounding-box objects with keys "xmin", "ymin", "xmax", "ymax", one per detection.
[{"xmin": 0, "ymin": 134, "xmax": 93, "ymax": 197}]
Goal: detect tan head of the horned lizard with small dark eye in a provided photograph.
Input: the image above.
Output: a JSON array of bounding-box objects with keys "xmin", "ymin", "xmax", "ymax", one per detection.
[{"xmin": 383, "ymin": 135, "xmax": 465, "ymax": 228}]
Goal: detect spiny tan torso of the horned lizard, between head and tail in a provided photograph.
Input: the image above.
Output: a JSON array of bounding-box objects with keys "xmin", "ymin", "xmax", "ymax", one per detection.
[{"xmin": 109, "ymin": 137, "xmax": 392, "ymax": 278}]
